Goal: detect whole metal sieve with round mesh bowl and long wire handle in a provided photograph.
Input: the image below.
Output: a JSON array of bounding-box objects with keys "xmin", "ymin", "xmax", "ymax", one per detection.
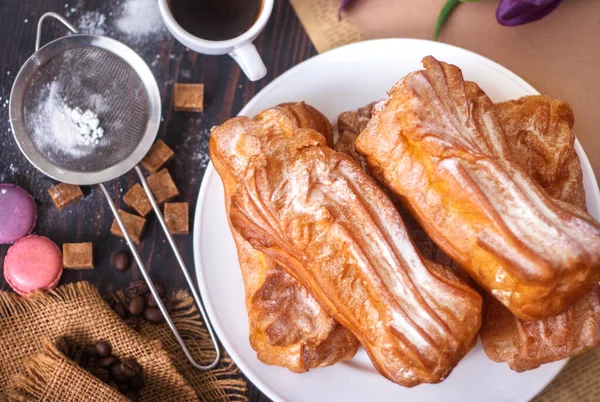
[{"xmin": 10, "ymin": 13, "xmax": 220, "ymax": 370}]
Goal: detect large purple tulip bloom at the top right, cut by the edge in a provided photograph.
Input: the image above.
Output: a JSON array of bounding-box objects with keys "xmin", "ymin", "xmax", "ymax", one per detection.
[{"xmin": 496, "ymin": 0, "xmax": 562, "ymax": 26}]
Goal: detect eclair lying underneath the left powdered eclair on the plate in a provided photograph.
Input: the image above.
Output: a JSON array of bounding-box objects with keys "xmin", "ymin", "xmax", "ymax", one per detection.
[{"xmin": 210, "ymin": 103, "xmax": 358, "ymax": 372}]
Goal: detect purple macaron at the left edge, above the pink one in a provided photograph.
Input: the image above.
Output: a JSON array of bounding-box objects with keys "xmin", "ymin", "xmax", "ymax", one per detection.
[{"xmin": 0, "ymin": 183, "xmax": 37, "ymax": 244}]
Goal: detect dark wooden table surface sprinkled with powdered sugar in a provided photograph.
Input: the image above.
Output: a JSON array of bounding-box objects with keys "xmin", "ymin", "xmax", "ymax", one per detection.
[{"xmin": 0, "ymin": 0, "xmax": 316, "ymax": 401}]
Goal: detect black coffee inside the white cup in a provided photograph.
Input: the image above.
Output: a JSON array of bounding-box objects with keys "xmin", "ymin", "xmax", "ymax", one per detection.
[{"xmin": 169, "ymin": 0, "xmax": 262, "ymax": 40}]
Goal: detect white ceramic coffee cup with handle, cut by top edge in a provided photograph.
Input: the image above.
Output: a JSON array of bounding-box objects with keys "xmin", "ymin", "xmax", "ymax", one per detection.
[{"xmin": 158, "ymin": 0, "xmax": 274, "ymax": 81}]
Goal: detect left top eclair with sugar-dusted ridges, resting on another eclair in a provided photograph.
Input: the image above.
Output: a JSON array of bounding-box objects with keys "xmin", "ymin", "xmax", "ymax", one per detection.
[{"xmin": 216, "ymin": 105, "xmax": 482, "ymax": 386}]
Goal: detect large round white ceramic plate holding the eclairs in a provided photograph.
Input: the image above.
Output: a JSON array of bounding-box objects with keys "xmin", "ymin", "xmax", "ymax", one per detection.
[{"xmin": 194, "ymin": 39, "xmax": 600, "ymax": 402}]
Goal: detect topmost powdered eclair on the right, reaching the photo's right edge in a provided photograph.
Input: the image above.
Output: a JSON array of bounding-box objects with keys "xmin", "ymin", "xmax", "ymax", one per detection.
[{"xmin": 355, "ymin": 56, "xmax": 600, "ymax": 320}]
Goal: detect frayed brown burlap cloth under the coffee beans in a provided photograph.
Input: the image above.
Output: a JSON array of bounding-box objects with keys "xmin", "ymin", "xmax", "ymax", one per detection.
[{"xmin": 0, "ymin": 282, "xmax": 247, "ymax": 402}]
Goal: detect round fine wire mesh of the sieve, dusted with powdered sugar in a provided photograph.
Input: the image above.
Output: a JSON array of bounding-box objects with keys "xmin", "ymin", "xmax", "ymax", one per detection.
[{"xmin": 23, "ymin": 45, "xmax": 149, "ymax": 172}]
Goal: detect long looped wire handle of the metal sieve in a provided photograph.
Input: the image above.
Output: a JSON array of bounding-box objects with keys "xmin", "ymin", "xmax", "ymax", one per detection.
[{"xmin": 100, "ymin": 166, "xmax": 221, "ymax": 371}]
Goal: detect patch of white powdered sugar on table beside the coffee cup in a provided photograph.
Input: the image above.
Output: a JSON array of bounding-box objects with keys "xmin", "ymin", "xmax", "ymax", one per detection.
[{"xmin": 116, "ymin": 0, "xmax": 166, "ymax": 39}]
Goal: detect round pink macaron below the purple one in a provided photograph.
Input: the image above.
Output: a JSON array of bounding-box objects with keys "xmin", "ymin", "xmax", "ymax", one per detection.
[{"xmin": 4, "ymin": 235, "xmax": 63, "ymax": 296}]
